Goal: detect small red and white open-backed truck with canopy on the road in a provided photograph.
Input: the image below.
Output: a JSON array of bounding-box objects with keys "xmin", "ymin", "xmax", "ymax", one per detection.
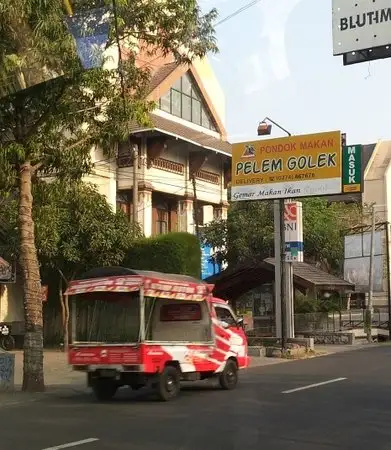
[{"xmin": 67, "ymin": 267, "xmax": 249, "ymax": 401}]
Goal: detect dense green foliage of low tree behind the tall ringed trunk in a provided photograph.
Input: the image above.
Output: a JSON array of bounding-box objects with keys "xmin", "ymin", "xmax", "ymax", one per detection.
[{"xmin": 3, "ymin": 181, "xmax": 141, "ymax": 280}]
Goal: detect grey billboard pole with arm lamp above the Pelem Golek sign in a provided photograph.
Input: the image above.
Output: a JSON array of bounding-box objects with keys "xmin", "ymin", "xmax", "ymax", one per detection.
[{"xmin": 257, "ymin": 117, "xmax": 293, "ymax": 352}]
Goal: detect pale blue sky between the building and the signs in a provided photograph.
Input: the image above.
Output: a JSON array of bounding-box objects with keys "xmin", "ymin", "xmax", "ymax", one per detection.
[{"xmin": 200, "ymin": 0, "xmax": 391, "ymax": 144}]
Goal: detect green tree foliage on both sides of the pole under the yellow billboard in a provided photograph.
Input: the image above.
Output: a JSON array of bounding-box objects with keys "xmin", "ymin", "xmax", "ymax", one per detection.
[{"xmin": 202, "ymin": 198, "xmax": 361, "ymax": 273}]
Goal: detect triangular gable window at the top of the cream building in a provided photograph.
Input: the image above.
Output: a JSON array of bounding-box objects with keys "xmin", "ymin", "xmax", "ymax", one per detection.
[{"xmin": 159, "ymin": 73, "xmax": 217, "ymax": 131}]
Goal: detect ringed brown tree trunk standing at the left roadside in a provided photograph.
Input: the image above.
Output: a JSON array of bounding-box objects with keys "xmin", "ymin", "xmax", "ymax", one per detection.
[{"xmin": 19, "ymin": 162, "xmax": 45, "ymax": 392}]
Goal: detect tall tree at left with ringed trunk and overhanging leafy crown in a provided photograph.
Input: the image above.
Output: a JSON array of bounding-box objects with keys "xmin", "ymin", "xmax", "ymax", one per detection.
[{"xmin": 0, "ymin": 0, "xmax": 216, "ymax": 391}]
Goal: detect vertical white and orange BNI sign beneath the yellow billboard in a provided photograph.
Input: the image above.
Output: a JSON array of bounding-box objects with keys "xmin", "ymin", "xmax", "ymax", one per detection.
[{"xmin": 284, "ymin": 201, "xmax": 304, "ymax": 262}]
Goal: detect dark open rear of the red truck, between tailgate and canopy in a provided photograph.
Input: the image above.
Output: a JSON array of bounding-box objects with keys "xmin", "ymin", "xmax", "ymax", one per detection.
[{"xmin": 75, "ymin": 292, "xmax": 140, "ymax": 344}]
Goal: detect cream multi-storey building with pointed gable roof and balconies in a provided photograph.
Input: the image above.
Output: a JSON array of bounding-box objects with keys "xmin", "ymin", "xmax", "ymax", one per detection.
[{"xmin": 89, "ymin": 50, "xmax": 231, "ymax": 236}]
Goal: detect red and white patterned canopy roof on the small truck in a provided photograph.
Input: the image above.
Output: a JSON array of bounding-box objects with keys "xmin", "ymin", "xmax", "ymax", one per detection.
[{"xmin": 65, "ymin": 267, "xmax": 214, "ymax": 301}]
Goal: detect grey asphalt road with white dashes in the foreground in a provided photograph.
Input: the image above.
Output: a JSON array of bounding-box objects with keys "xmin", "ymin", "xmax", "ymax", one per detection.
[{"xmin": 0, "ymin": 346, "xmax": 391, "ymax": 450}]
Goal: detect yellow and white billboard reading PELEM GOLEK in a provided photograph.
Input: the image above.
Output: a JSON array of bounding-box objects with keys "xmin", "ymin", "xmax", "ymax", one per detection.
[{"xmin": 231, "ymin": 131, "xmax": 342, "ymax": 201}]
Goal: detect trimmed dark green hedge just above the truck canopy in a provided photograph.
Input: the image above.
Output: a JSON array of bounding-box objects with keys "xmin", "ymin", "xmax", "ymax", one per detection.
[{"xmin": 124, "ymin": 233, "xmax": 201, "ymax": 278}]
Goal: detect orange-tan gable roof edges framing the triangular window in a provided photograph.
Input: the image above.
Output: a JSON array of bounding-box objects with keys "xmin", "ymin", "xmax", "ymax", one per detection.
[{"xmin": 149, "ymin": 62, "xmax": 227, "ymax": 139}]
